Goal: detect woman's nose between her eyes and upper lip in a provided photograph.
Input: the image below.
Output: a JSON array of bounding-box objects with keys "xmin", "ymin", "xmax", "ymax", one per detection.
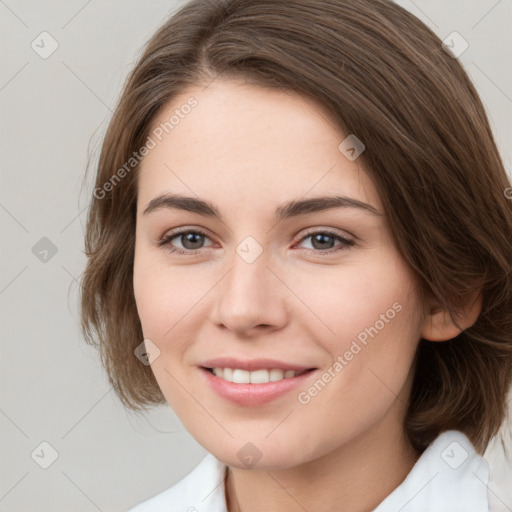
[{"xmin": 209, "ymin": 247, "xmax": 289, "ymax": 337}]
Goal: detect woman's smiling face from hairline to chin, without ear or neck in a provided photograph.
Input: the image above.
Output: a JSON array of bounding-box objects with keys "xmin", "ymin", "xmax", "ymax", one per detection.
[{"xmin": 134, "ymin": 79, "xmax": 423, "ymax": 469}]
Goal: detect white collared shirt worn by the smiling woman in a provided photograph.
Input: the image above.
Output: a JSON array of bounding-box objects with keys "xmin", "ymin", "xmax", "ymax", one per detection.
[{"xmin": 128, "ymin": 430, "xmax": 510, "ymax": 512}]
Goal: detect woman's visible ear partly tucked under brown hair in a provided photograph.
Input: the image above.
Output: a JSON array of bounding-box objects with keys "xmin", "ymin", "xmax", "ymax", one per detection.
[{"xmin": 421, "ymin": 292, "xmax": 482, "ymax": 341}]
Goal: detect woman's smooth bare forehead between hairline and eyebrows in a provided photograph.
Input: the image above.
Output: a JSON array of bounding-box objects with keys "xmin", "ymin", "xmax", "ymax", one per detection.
[{"xmin": 138, "ymin": 79, "xmax": 380, "ymax": 214}]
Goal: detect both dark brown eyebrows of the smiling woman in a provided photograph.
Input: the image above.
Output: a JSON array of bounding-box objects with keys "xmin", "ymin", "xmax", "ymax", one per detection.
[{"xmin": 143, "ymin": 194, "xmax": 383, "ymax": 222}]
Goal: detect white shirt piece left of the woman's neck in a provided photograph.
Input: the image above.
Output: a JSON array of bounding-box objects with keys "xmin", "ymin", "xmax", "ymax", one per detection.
[{"xmin": 128, "ymin": 453, "xmax": 226, "ymax": 512}]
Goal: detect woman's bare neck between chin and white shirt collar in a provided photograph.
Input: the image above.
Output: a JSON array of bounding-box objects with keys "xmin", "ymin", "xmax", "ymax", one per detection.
[{"xmin": 225, "ymin": 416, "xmax": 419, "ymax": 512}]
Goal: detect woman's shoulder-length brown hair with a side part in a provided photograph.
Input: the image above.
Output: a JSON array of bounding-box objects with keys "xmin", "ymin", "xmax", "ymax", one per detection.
[{"xmin": 81, "ymin": 0, "xmax": 512, "ymax": 453}]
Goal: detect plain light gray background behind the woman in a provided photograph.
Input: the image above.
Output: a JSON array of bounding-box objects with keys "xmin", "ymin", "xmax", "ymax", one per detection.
[{"xmin": 0, "ymin": 0, "xmax": 512, "ymax": 512}]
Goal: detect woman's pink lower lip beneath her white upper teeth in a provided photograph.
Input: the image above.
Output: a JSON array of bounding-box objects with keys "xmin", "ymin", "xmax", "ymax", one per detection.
[{"xmin": 200, "ymin": 368, "xmax": 315, "ymax": 406}]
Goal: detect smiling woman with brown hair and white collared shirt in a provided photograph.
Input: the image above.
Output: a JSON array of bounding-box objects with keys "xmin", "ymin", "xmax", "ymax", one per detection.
[{"xmin": 82, "ymin": 0, "xmax": 512, "ymax": 512}]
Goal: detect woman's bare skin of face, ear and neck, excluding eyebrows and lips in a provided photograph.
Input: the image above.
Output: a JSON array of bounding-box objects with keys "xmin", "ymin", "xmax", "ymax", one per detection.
[{"xmin": 134, "ymin": 79, "xmax": 477, "ymax": 512}]
